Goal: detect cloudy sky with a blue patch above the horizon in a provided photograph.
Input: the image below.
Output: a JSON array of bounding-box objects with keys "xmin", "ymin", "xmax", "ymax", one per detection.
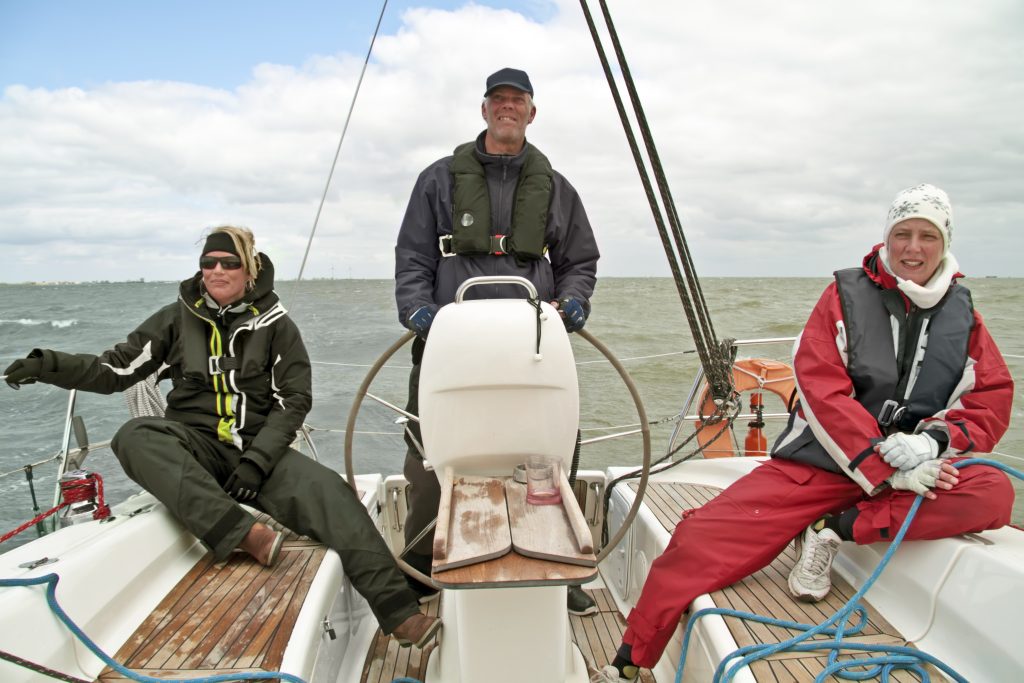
[{"xmin": 0, "ymin": 0, "xmax": 1024, "ymax": 283}]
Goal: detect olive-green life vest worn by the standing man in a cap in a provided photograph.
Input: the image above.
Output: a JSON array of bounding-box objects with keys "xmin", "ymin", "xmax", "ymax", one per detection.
[{"xmin": 452, "ymin": 141, "xmax": 554, "ymax": 260}]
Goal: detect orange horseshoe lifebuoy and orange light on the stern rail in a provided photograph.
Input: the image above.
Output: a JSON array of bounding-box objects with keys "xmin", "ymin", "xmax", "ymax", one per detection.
[{"xmin": 694, "ymin": 358, "xmax": 797, "ymax": 458}]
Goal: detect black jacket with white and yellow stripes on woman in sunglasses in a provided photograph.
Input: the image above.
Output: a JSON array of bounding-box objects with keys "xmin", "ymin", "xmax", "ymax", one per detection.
[{"xmin": 33, "ymin": 254, "xmax": 312, "ymax": 472}]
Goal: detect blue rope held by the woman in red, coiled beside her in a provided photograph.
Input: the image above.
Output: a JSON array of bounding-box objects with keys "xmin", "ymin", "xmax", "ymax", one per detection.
[{"xmin": 675, "ymin": 458, "xmax": 1024, "ymax": 683}]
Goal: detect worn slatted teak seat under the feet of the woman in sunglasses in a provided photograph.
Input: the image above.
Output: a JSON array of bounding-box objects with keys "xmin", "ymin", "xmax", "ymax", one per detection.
[{"xmin": 97, "ymin": 516, "xmax": 326, "ymax": 683}]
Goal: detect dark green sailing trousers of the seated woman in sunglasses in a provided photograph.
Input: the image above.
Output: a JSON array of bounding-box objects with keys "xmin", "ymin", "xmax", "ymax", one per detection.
[{"xmin": 112, "ymin": 417, "xmax": 419, "ymax": 633}]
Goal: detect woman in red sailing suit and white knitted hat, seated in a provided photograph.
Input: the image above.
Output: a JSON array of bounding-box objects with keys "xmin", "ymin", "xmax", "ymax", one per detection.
[{"xmin": 595, "ymin": 184, "xmax": 1014, "ymax": 682}]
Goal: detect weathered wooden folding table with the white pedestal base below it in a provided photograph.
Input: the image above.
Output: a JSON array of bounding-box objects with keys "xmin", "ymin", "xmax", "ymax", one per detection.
[{"xmin": 427, "ymin": 468, "xmax": 597, "ymax": 683}]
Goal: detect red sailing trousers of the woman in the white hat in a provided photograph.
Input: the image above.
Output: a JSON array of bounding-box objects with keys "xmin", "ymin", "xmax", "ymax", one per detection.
[{"xmin": 623, "ymin": 459, "xmax": 1014, "ymax": 669}]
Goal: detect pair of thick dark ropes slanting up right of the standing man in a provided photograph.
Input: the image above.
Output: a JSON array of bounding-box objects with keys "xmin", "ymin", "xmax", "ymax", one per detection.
[{"xmin": 580, "ymin": 0, "xmax": 734, "ymax": 402}]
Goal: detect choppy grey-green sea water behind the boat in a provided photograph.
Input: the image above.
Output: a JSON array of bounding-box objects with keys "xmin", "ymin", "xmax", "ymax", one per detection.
[{"xmin": 0, "ymin": 278, "xmax": 1024, "ymax": 552}]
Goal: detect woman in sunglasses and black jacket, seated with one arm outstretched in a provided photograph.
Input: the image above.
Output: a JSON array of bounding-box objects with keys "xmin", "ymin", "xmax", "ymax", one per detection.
[{"xmin": 5, "ymin": 226, "xmax": 440, "ymax": 646}]
